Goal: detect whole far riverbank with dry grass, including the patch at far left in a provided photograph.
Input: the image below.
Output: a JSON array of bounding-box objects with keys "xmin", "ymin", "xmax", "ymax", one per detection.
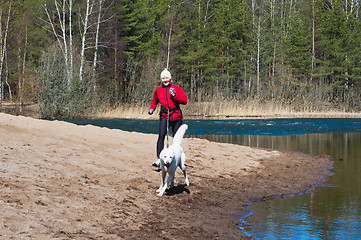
[{"xmin": 0, "ymin": 102, "xmax": 361, "ymax": 119}]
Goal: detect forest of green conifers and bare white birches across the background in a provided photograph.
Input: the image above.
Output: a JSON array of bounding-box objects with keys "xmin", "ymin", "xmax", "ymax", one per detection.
[{"xmin": 0, "ymin": 0, "xmax": 361, "ymax": 117}]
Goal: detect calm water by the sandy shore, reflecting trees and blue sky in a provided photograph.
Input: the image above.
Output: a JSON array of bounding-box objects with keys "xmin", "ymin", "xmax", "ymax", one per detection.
[{"xmin": 236, "ymin": 132, "xmax": 361, "ymax": 240}]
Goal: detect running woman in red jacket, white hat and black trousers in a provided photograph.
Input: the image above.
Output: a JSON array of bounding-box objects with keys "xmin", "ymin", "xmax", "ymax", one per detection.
[{"xmin": 148, "ymin": 68, "xmax": 188, "ymax": 167}]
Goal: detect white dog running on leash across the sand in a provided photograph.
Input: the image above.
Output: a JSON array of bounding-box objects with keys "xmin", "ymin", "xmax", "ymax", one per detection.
[{"xmin": 157, "ymin": 124, "xmax": 189, "ymax": 196}]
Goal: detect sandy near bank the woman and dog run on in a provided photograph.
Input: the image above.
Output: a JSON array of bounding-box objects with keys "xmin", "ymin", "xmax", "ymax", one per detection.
[{"xmin": 0, "ymin": 113, "xmax": 330, "ymax": 239}]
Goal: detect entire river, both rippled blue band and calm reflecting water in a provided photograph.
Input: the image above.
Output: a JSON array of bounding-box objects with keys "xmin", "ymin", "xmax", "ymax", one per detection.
[{"xmin": 60, "ymin": 119, "xmax": 361, "ymax": 239}]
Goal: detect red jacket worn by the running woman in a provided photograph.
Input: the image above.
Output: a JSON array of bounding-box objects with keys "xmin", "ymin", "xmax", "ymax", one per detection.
[{"xmin": 149, "ymin": 83, "xmax": 188, "ymax": 121}]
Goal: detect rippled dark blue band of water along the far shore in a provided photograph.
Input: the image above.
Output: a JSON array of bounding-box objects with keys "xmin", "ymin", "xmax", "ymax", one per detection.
[{"xmin": 59, "ymin": 118, "xmax": 361, "ymax": 136}]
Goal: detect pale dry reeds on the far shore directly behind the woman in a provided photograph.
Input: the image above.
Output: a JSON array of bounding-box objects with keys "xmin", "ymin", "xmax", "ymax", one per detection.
[{"xmin": 94, "ymin": 101, "xmax": 361, "ymax": 119}]
